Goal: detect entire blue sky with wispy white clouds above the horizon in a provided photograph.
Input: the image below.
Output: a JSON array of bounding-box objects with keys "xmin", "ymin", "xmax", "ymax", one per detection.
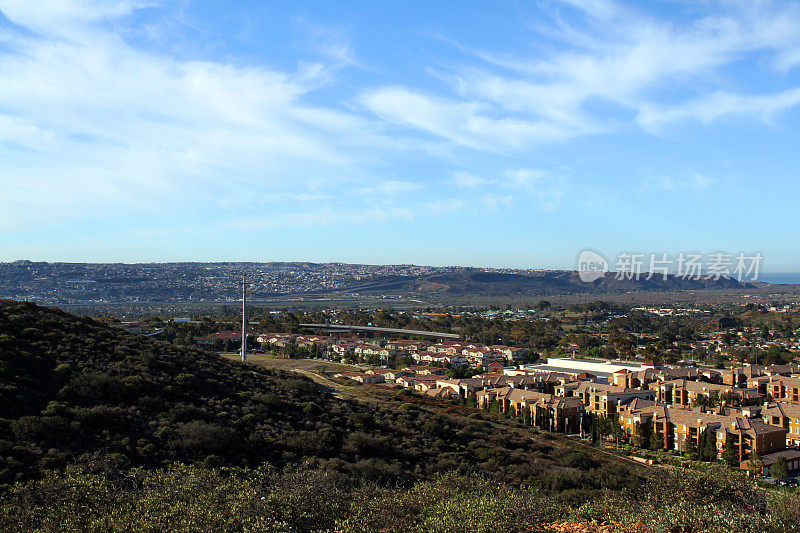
[{"xmin": 0, "ymin": 0, "xmax": 800, "ymax": 272}]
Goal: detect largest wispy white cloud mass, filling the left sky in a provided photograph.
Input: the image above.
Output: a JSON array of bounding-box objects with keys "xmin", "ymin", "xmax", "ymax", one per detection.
[{"xmin": 0, "ymin": 0, "xmax": 403, "ymax": 227}]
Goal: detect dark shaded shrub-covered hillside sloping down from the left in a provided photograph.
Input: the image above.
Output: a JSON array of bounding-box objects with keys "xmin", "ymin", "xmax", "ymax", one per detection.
[{"xmin": 0, "ymin": 301, "xmax": 640, "ymax": 494}]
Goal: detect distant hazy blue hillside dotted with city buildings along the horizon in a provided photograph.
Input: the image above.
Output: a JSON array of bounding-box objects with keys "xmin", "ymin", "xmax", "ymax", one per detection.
[{"xmin": 0, "ymin": 261, "xmax": 754, "ymax": 305}]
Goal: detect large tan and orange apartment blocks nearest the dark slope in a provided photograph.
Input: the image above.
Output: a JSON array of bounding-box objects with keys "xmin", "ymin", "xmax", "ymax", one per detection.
[{"xmin": 477, "ymin": 370, "xmax": 800, "ymax": 474}]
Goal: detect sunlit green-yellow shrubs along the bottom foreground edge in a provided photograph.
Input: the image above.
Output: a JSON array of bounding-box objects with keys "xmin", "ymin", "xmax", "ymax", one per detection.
[{"xmin": 0, "ymin": 464, "xmax": 800, "ymax": 533}]
